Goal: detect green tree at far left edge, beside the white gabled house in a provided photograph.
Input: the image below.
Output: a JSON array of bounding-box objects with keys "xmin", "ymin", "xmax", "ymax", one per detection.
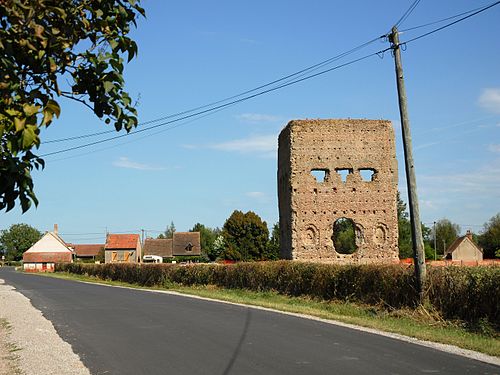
[{"xmin": 0, "ymin": 224, "xmax": 42, "ymax": 260}]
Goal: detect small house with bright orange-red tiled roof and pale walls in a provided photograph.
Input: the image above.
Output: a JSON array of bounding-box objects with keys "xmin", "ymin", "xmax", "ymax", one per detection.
[{"xmin": 104, "ymin": 234, "xmax": 142, "ymax": 263}]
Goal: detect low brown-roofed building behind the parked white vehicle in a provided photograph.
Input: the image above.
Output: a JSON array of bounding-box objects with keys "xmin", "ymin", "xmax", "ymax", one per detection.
[{"xmin": 144, "ymin": 232, "xmax": 201, "ymax": 258}]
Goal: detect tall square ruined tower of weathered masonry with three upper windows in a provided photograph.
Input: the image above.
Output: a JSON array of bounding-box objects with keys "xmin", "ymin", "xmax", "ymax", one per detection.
[{"xmin": 278, "ymin": 119, "xmax": 398, "ymax": 263}]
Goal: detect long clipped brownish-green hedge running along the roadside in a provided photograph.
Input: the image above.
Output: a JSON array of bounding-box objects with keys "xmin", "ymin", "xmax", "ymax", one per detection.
[{"xmin": 56, "ymin": 261, "xmax": 500, "ymax": 326}]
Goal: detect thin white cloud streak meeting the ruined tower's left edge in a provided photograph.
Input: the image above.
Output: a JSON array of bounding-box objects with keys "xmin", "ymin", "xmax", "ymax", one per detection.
[{"xmin": 210, "ymin": 134, "xmax": 278, "ymax": 157}]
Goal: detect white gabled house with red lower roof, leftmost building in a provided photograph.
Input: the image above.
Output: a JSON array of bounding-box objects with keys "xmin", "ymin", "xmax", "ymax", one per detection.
[{"xmin": 23, "ymin": 224, "xmax": 73, "ymax": 272}]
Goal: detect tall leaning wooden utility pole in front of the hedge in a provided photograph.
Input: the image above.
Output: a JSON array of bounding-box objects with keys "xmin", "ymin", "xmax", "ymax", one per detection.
[{"xmin": 389, "ymin": 26, "xmax": 426, "ymax": 302}]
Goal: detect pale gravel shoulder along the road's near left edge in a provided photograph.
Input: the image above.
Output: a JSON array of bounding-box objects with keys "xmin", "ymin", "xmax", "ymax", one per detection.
[{"xmin": 0, "ymin": 279, "xmax": 90, "ymax": 375}]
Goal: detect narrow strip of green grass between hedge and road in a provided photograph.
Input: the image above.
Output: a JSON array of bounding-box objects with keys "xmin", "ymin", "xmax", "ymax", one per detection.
[{"xmin": 45, "ymin": 272, "xmax": 500, "ymax": 357}]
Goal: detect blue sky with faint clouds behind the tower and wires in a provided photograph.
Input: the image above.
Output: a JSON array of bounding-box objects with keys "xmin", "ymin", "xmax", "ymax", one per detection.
[{"xmin": 0, "ymin": 0, "xmax": 500, "ymax": 243}]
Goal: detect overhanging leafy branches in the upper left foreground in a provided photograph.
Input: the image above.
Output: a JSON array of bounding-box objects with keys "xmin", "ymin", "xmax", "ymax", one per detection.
[{"xmin": 0, "ymin": 0, "xmax": 144, "ymax": 212}]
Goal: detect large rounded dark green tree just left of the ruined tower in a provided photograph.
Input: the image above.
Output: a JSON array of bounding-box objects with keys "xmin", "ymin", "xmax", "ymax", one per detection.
[{"xmin": 222, "ymin": 210, "xmax": 269, "ymax": 260}]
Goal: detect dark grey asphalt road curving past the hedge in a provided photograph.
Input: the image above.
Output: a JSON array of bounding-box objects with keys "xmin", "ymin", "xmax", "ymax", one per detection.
[{"xmin": 0, "ymin": 268, "xmax": 500, "ymax": 375}]
